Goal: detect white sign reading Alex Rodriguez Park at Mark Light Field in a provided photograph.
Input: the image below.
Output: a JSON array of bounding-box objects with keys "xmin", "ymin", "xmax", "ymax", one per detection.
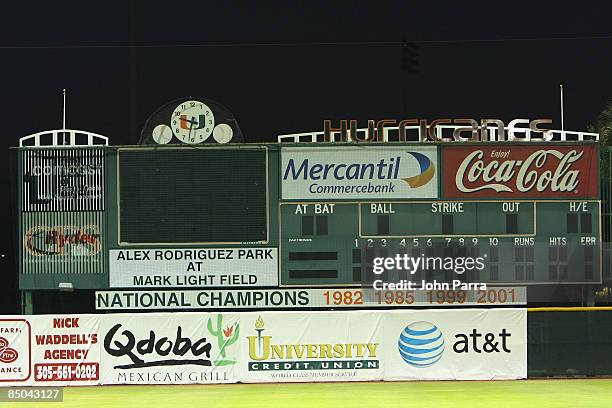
[{"xmin": 109, "ymin": 248, "xmax": 278, "ymax": 288}]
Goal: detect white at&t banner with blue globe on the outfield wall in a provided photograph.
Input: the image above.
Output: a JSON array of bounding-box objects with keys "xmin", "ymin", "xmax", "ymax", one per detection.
[{"xmin": 381, "ymin": 309, "xmax": 527, "ymax": 381}]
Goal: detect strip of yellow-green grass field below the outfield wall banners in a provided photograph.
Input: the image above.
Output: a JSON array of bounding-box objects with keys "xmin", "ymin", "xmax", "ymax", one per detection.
[{"xmin": 0, "ymin": 379, "xmax": 612, "ymax": 408}]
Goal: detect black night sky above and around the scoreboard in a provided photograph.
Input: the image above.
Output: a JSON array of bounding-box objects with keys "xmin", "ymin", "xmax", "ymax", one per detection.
[{"xmin": 0, "ymin": 1, "xmax": 612, "ymax": 314}]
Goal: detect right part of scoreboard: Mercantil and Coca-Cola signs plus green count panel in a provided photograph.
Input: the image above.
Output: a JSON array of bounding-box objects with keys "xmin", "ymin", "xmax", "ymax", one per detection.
[{"xmin": 280, "ymin": 143, "xmax": 602, "ymax": 285}]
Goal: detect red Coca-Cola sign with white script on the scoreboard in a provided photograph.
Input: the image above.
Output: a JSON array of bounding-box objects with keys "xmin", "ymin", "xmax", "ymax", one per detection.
[{"xmin": 442, "ymin": 144, "xmax": 599, "ymax": 198}]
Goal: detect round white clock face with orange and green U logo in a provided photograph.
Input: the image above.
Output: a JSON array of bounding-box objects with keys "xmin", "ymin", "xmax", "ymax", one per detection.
[{"xmin": 170, "ymin": 101, "xmax": 215, "ymax": 144}]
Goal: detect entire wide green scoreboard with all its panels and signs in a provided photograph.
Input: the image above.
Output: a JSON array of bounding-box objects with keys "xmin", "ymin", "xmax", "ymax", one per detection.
[{"xmin": 19, "ymin": 142, "xmax": 602, "ymax": 309}]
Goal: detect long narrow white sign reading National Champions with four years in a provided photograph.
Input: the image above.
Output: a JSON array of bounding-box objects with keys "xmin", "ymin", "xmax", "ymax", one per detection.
[{"xmin": 96, "ymin": 287, "xmax": 527, "ymax": 310}]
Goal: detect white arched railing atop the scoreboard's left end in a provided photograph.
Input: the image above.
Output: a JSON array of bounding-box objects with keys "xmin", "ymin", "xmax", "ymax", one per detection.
[{"xmin": 19, "ymin": 129, "xmax": 108, "ymax": 147}]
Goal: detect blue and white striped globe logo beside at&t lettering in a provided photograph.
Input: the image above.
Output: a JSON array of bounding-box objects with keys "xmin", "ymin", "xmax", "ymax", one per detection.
[{"xmin": 397, "ymin": 321, "xmax": 444, "ymax": 368}]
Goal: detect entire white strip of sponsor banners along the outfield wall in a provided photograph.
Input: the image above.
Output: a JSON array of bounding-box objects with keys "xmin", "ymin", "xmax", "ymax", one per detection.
[{"xmin": 0, "ymin": 309, "xmax": 527, "ymax": 386}]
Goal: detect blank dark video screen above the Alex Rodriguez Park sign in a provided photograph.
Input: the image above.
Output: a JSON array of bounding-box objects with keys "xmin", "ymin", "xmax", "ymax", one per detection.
[{"xmin": 117, "ymin": 149, "xmax": 268, "ymax": 245}]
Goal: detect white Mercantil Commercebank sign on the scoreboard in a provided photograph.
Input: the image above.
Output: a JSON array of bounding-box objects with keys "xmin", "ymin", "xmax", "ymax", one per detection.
[{"xmin": 281, "ymin": 146, "xmax": 439, "ymax": 200}]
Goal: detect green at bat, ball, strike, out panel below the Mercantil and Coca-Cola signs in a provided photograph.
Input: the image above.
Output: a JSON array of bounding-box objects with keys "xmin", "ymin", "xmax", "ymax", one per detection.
[{"xmin": 280, "ymin": 201, "xmax": 601, "ymax": 286}]
